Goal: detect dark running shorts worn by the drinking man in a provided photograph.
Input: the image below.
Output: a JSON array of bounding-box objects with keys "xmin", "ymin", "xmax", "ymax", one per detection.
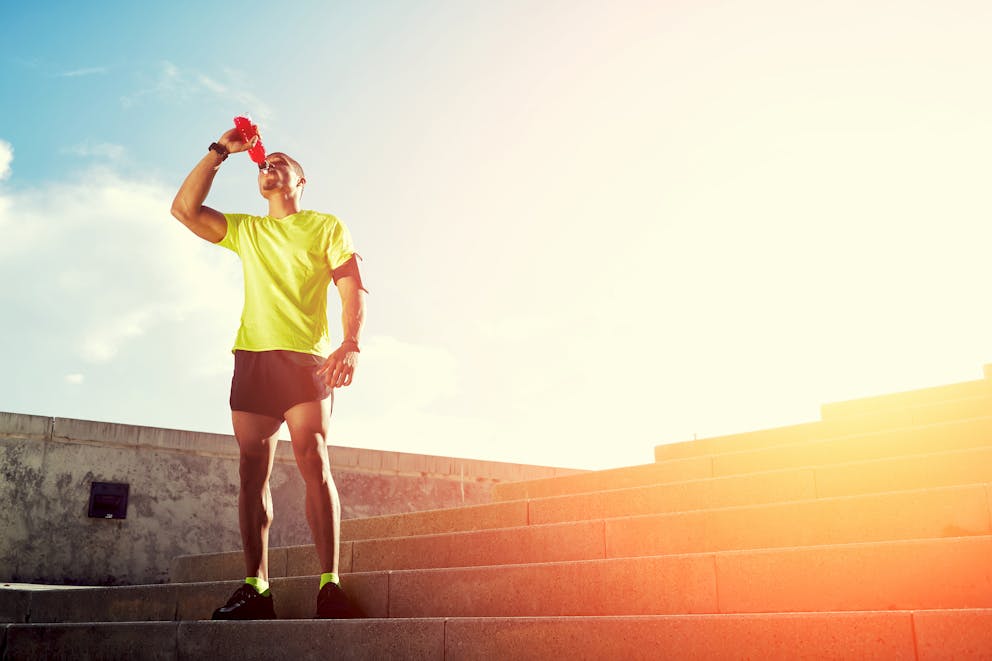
[{"xmin": 231, "ymin": 349, "xmax": 334, "ymax": 420}]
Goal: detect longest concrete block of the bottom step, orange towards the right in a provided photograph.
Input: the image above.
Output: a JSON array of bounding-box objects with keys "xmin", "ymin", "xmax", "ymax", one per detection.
[{"xmin": 445, "ymin": 613, "xmax": 915, "ymax": 661}]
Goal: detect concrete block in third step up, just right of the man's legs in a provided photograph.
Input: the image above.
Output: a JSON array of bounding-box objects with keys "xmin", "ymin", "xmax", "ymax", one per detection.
[{"xmin": 354, "ymin": 520, "xmax": 608, "ymax": 571}]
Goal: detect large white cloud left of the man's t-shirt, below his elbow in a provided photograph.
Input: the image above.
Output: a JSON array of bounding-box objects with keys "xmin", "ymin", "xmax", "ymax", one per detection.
[{"xmin": 0, "ymin": 169, "xmax": 241, "ymax": 365}]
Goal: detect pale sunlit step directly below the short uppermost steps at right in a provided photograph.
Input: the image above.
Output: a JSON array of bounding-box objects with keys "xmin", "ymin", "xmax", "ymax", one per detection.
[{"xmin": 655, "ymin": 382, "xmax": 992, "ymax": 462}]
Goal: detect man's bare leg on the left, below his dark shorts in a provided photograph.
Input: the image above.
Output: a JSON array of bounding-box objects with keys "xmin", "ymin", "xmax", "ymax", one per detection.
[{"xmin": 231, "ymin": 411, "xmax": 282, "ymax": 581}]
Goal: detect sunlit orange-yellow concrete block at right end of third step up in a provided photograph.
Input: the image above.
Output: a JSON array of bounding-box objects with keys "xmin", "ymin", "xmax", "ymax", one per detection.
[{"xmin": 605, "ymin": 485, "xmax": 992, "ymax": 558}]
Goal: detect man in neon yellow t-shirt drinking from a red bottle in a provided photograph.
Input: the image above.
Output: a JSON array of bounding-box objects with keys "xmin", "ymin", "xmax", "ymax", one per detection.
[{"xmin": 172, "ymin": 129, "xmax": 365, "ymax": 620}]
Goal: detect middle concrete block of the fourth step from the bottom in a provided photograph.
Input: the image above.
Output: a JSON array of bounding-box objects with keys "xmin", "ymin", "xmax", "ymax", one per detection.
[{"xmin": 530, "ymin": 470, "xmax": 815, "ymax": 524}]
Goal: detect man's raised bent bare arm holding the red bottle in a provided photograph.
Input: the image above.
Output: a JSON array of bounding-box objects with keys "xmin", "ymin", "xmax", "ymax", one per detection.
[{"xmin": 172, "ymin": 129, "xmax": 257, "ymax": 243}]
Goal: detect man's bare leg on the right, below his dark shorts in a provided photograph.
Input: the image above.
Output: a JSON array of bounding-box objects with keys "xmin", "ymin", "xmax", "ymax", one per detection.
[{"xmin": 286, "ymin": 400, "xmax": 341, "ymax": 573}]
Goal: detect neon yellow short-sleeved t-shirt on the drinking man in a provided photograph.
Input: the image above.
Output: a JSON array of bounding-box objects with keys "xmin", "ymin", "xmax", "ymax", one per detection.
[{"xmin": 217, "ymin": 211, "xmax": 355, "ymax": 356}]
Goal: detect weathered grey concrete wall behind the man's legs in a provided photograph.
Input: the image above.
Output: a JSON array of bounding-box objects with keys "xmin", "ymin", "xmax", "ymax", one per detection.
[{"xmin": 0, "ymin": 412, "xmax": 578, "ymax": 585}]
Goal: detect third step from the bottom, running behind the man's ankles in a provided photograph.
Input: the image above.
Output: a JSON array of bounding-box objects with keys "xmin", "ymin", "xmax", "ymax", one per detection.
[{"xmin": 175, "ymin": 484, "xmax": 992, "ymax": 582}]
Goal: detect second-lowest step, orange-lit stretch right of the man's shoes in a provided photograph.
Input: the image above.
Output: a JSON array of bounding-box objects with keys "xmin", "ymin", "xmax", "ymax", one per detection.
[{"xmin": 389, "ymin": 536, "xmax": 992, "ymax": 617}]
